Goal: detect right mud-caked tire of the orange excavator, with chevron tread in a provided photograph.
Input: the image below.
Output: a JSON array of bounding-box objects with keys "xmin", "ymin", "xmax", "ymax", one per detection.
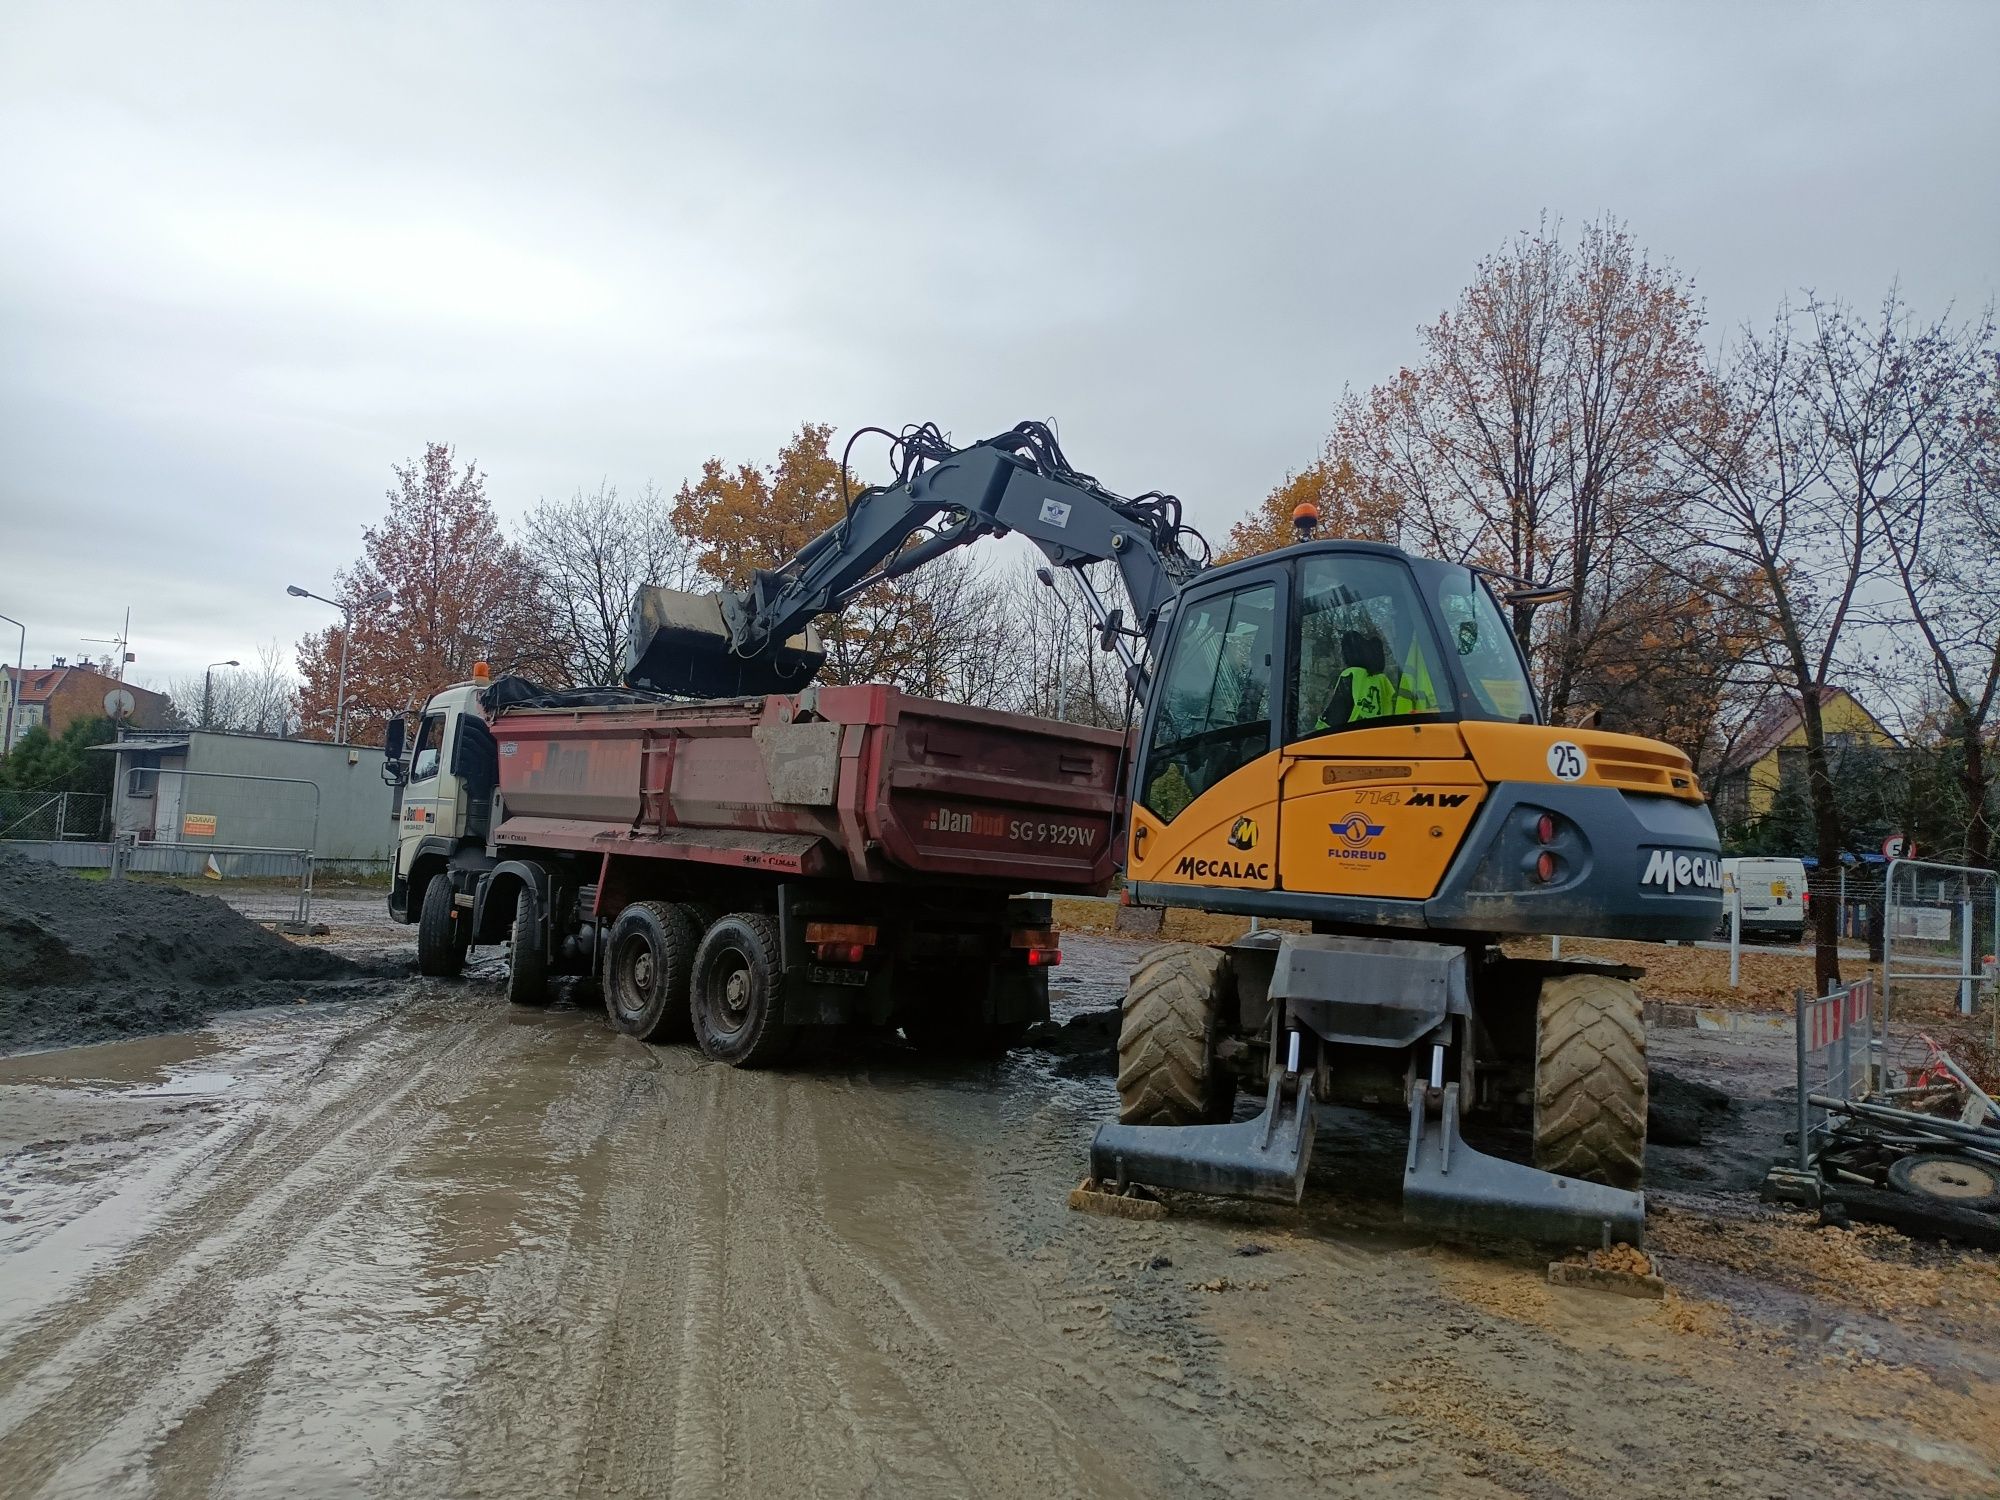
[{"xmin": 1534, "ymin": 974, "xmax": 1646, "ymax": 1188}]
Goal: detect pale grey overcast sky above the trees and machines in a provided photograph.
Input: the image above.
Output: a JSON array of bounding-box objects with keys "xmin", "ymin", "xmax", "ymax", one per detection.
[{"xmin": 0, "ymin": 0, "xmax": 2000, "ymax": 682}]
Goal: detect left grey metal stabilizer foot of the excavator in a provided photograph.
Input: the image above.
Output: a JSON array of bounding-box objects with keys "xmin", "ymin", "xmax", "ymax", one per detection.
[{"xmin": 1090, "ymin": 1072, "xmax": 1314, "ymax": 1204}]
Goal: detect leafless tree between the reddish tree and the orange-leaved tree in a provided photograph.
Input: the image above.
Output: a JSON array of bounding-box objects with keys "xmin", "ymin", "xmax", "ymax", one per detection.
[{"xmin": 520, "ymin": 480, "xmax": 696, "ymax": 686}]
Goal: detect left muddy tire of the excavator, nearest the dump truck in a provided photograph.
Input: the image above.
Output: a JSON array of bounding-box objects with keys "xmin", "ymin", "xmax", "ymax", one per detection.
[{"xmin": 1118, "ymin": 942, "xmax": 1236, "ymax": 1124}]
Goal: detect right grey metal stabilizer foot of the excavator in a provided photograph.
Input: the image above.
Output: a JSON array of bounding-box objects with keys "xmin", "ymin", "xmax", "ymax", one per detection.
[{"xmin": 1402, "ymin": 1080, "xmax": 1646, "ymax": 1246}]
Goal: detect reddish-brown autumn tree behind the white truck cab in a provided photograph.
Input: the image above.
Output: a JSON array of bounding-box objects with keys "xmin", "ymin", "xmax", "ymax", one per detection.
[{"xmin": 294, "ymin": 442, "xmax": 562, "ymax": 742}]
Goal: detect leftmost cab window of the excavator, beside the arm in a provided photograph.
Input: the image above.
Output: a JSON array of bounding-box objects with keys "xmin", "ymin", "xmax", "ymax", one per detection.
[{"xmin": 1140, "ymin": 582, "xmax": 1278, "ymax": 822}]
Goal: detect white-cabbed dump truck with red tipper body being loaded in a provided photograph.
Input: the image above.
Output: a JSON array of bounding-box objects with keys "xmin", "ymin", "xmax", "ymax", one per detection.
[{"xmin": 388, "ymin": 678, "xmax": 1124, "ymax": 1066}]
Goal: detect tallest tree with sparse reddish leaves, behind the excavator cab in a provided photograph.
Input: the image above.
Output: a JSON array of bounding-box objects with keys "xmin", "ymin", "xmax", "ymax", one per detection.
[{"xmin": 1322, "ymin": 220, "xmax": 1704, "ymax": 720}]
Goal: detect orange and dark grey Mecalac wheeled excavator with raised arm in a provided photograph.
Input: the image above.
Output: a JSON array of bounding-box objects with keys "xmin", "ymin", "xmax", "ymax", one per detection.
[{"xmin": 626, "ymin": 422, "xmax": 1722, "ymax": 1244}]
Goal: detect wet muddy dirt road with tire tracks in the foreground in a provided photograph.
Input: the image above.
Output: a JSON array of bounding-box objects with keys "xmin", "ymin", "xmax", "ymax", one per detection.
[{"xmin": 0, "ymin": 900, "xmax": 2000, "ymax": 1500}]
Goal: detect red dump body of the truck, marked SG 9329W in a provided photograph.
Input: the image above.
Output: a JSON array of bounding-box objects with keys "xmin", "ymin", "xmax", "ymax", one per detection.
[{"xmin": 492, "ymin": 686, "xmax": 1124, "ymax": 892}]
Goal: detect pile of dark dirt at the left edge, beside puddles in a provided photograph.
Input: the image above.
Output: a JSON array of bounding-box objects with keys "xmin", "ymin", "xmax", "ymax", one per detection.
[{"xmin": 0, "ymin": 856, "xmax": 362, "ymax": 1050}]
